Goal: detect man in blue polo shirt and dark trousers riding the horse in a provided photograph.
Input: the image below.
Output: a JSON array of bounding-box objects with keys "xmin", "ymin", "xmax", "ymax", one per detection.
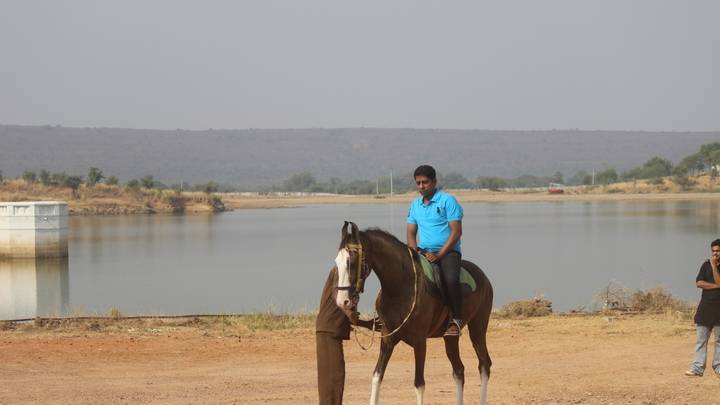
[{"xmin": 407, "ymin": 165, "xmax": 463, "ymax": 336}]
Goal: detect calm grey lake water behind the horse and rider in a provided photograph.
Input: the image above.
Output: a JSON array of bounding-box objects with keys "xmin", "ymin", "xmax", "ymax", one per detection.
[{"xmin": 0, "ymin": 201, "xmax": 720, "ymax": 314}]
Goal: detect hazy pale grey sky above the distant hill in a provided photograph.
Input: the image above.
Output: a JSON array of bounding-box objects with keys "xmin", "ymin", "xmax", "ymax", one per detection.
[{"xmin": 0, "ymin": 0, "xmax": 720, "ymax": 131}]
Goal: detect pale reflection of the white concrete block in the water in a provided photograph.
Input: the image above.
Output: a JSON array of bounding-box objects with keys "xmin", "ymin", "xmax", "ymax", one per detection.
[{"xmin": 0, "ymin": 257, "xmax": 70, "ymax": 320}]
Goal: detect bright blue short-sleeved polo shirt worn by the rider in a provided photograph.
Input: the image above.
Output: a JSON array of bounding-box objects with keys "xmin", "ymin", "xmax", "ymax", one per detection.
[{"xmin": 407, "ymin": 190, "xmax": 463, "ymax": 252}]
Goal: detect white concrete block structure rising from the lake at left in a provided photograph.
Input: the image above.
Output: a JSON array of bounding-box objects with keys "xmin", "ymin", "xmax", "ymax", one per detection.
[{"xmin": 0, "ymin": 201, "xmax": 68, "ymax": 259}]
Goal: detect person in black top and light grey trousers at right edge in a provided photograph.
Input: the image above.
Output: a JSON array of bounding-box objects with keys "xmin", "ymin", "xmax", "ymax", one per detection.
[{"xmin": 685, "ymin": 239, "xmax": 720, "ymax": 377}]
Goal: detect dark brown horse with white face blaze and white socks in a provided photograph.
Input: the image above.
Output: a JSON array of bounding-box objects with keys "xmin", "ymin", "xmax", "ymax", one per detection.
[{"xmin": 335, "ymin": 222, "xmax": 493, "ymax": 405}]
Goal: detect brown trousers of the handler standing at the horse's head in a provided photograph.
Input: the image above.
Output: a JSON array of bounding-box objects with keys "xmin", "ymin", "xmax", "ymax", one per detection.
[{"xmin": 315, "ymin": 332, "xmax": 345, "ymax": 405}]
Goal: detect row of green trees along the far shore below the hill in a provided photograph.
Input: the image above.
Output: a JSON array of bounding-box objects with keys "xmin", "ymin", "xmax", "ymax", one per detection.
[{"xmin": 5, "ymin": 142, "xmax": 720, "ymax": 194}]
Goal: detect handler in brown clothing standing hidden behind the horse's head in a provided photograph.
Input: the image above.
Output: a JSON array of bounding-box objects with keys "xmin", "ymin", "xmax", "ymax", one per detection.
[{"xmin": 315, "ymin": 267, "xmax": 379, "ymax": 405}]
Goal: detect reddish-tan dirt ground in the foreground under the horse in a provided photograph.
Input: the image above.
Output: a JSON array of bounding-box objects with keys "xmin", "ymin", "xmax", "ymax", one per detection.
[{"xmin": 0, "ymin": 314, "xmax": 720, "ymax": 404}]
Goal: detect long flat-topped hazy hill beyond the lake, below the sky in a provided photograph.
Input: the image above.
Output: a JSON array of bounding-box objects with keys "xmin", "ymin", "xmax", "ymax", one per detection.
[{"xmin": 0, "ymin": 125, "xmax": 720, "ymax": 188}]
